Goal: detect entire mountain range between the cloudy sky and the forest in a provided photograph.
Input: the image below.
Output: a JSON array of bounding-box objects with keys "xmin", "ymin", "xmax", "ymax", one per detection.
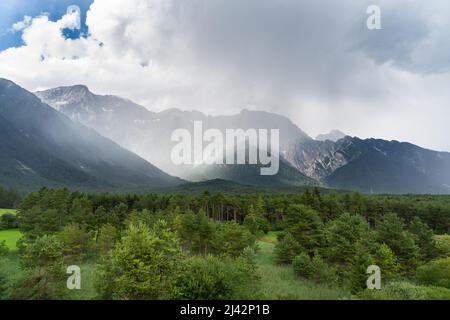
[{"xmin": 0, "ymin": 80, "xmax": 450, "ymax": 194}]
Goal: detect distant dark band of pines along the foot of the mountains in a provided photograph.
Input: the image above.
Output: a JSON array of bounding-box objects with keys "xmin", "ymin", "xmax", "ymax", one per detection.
[{"xmin": 15, "ymin": 188, "xmax": 450, "ymax": 234}]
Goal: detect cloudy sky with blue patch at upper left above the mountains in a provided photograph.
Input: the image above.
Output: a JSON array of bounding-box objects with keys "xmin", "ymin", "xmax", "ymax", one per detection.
[{"xmin": 0, "ymin": 0, "xmax": 450, "ymax": 151}]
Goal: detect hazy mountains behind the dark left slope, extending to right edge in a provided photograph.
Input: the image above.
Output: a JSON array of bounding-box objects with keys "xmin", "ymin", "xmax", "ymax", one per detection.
[{"xmin": 36, "ymin": 86, "xmax": 450, "ymax": 193}]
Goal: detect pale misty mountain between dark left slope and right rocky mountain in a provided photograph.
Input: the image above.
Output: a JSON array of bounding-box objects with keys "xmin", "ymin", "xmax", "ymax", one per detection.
[{"xmin": 36, "ymin": 86, "xmax": 311, "ymax": 185}]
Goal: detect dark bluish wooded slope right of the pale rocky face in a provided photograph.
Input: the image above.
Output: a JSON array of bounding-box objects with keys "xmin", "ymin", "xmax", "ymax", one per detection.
[{"xmin": 325, "ymin": 138, "xmax": 450, "ymax": 194}]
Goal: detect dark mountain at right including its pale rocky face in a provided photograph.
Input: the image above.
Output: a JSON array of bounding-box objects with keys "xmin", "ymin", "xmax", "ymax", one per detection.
[{"xmin": 286, "ymin": 136, "xmax": 450, "ymax": 194}]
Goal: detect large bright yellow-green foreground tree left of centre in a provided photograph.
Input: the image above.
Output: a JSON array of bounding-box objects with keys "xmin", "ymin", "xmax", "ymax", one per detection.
[{"xmin": 95, "ymin": 221, "xmax": 181, "ymax": 300}]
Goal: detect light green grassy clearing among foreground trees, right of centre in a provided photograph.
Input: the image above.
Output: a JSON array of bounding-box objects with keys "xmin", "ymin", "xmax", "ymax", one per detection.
[{"xmin": 257, "ymin": 232, "xmax": 351, "ymax": 300}]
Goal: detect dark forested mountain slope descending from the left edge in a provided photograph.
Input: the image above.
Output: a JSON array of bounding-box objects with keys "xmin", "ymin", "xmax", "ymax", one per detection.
[{"xmin": 0, "ymin": 79, "xmax": 182, "ymax": 191}]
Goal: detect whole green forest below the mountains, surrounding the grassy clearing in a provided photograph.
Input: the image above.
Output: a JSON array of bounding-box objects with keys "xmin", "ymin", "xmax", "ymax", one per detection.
[{"xmin": 0, "ymin": 188, "xmax": 450, "ymax": 299}]
